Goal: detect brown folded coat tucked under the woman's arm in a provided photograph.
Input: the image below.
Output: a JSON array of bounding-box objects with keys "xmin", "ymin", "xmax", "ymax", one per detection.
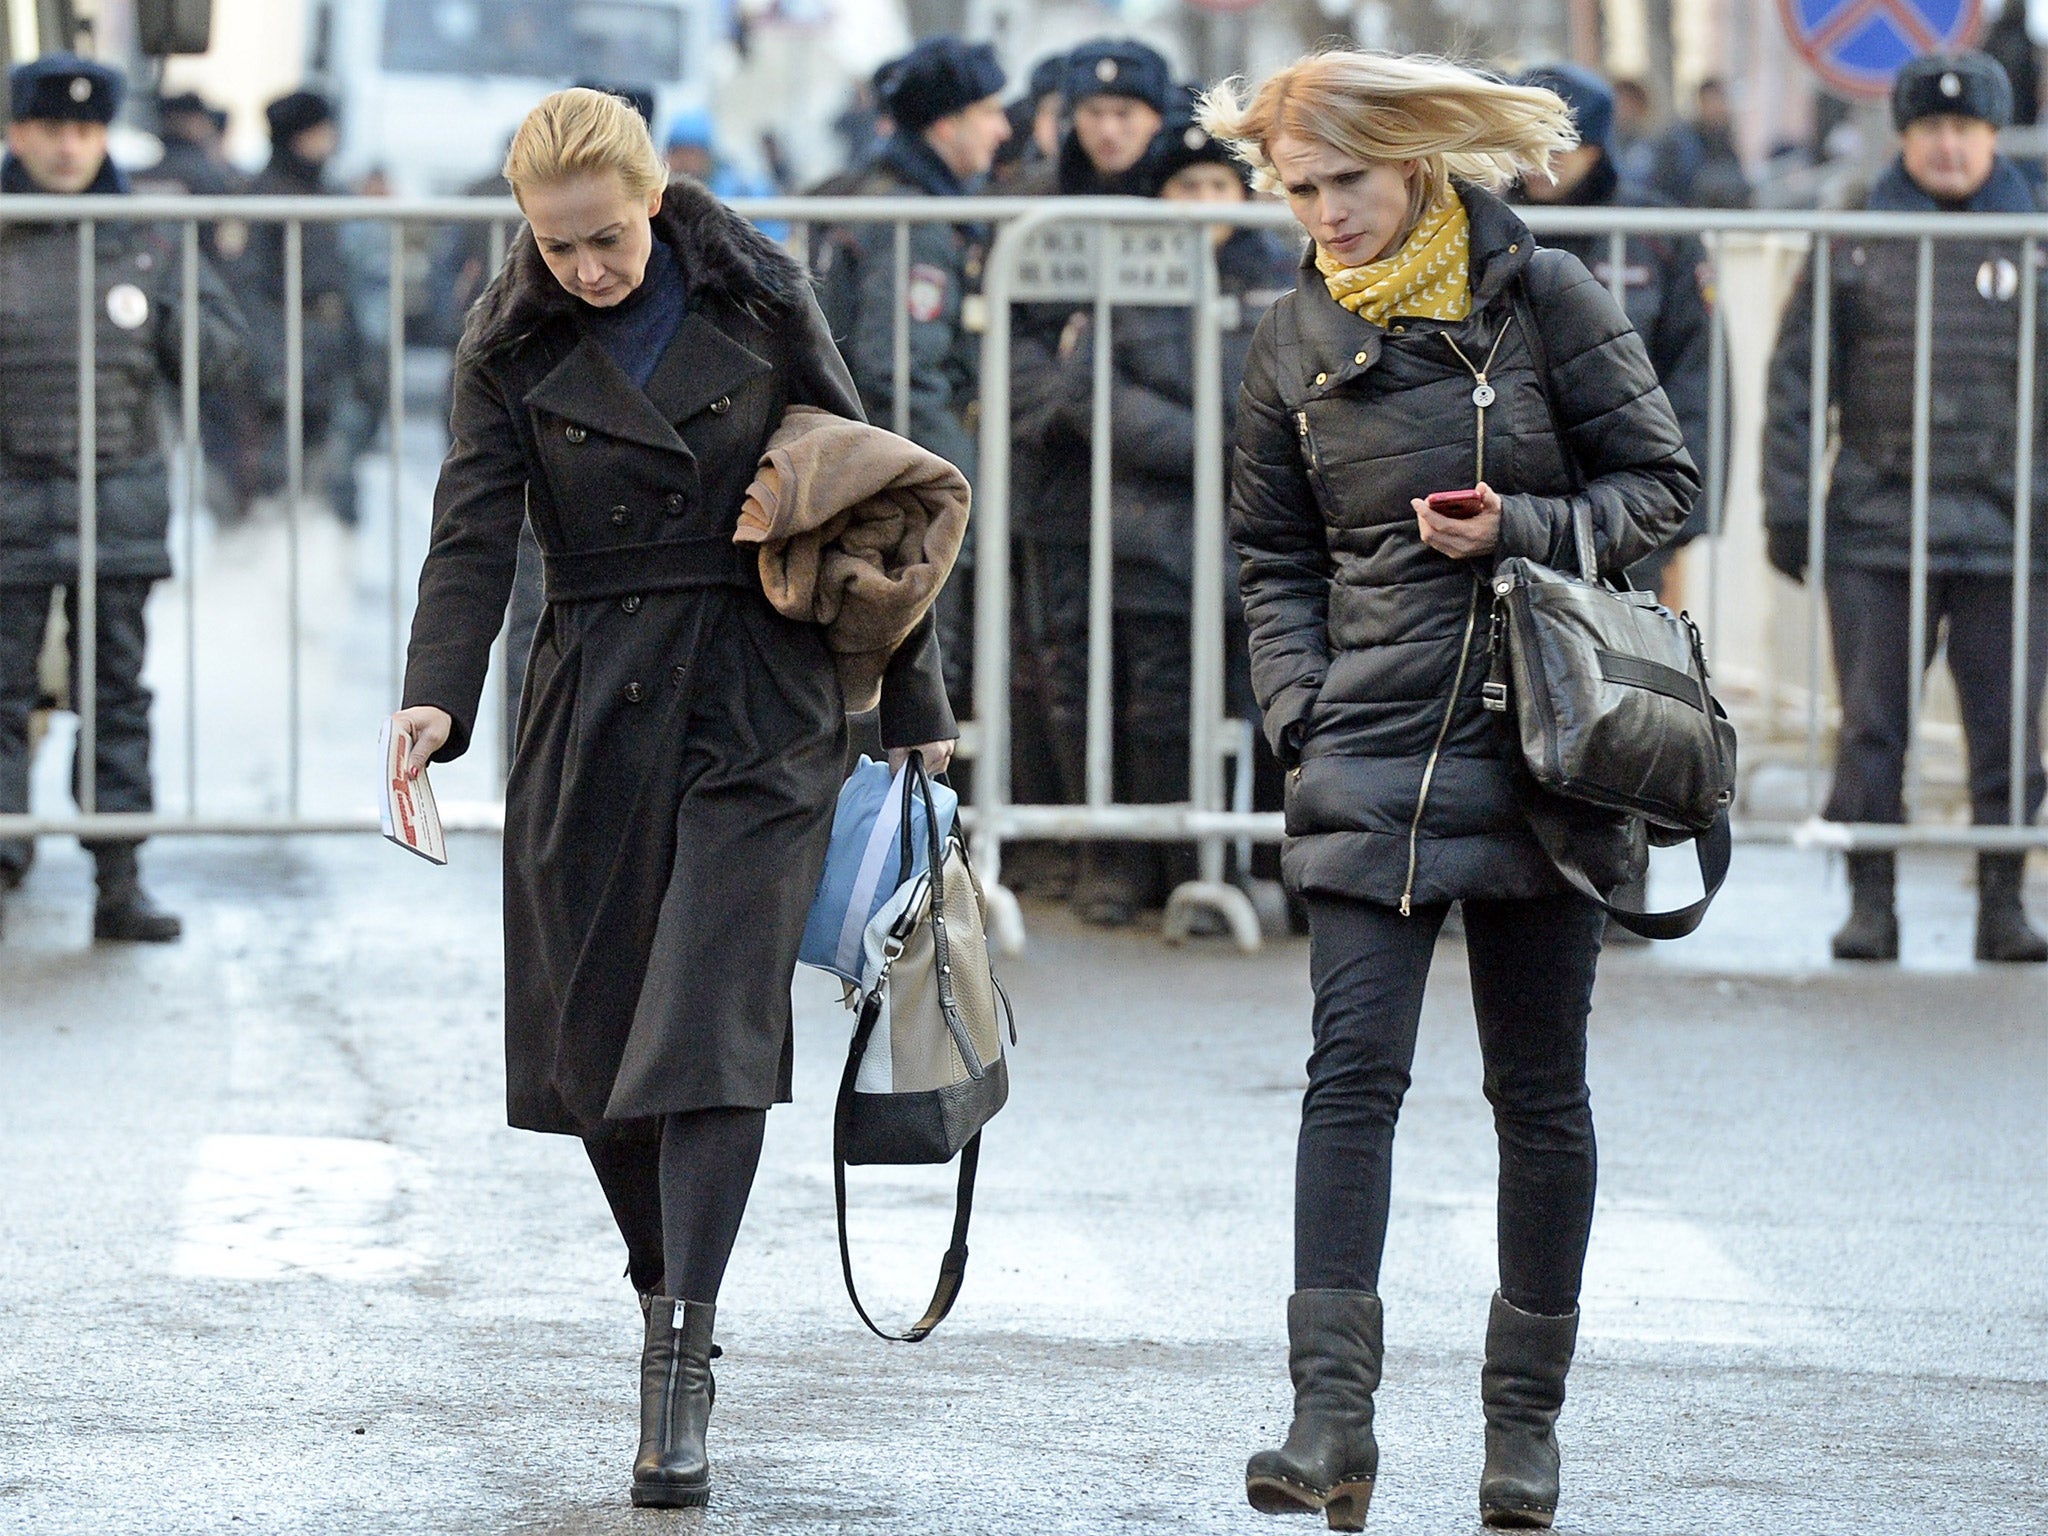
[{"xmin": 733, "ymin": 406, "xmax": 969, "ymax": 713}]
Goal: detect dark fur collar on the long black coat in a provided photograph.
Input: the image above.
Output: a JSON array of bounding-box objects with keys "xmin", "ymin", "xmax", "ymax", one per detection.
[{"xmin": 459, "ymin": 176, "xmax": 811, "ymax": 358}]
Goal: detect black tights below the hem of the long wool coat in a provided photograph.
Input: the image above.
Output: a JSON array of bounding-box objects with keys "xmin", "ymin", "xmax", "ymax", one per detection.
[{"xmin": 584, "ymin": 1110, "xmax": 768, "ymax": 1303}]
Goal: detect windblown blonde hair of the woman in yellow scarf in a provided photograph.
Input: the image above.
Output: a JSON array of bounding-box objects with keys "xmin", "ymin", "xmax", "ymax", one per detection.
[{"xmin": 1196, "ymin": 49, "xmax": 1579, "ymax": 213}]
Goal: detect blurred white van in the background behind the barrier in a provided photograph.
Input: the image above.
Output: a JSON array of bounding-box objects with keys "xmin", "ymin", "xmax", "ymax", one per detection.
[{"xmin": 305, "ymin": 0, "xmax": 717, "ymax": 195}]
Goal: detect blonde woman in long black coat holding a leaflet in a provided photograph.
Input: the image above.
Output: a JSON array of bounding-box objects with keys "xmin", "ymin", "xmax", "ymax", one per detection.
[{"xmin": 397, "ymin": 90, "xmax": 956, "ymax": 1507}]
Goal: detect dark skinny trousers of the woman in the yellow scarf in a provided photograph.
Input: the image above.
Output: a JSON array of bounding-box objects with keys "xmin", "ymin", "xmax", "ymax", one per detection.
[{"xmin": 1294, "ymin": 895, "xmax": 1606, "ymax": 1315}]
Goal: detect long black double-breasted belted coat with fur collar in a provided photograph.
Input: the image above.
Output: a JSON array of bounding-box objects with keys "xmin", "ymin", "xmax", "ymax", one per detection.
[{"xmin": 406, "ymin": 182, "xmax": 956, "ymax": 1135}]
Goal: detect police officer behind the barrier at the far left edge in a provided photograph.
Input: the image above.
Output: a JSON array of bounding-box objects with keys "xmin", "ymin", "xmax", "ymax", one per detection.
[{"xmin": 0, "ymin": 53, "xmax": 244, "ymax": 942}]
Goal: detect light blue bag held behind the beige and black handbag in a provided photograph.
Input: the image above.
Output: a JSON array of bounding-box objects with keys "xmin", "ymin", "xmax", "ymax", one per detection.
[{"xmin": 797, "ymin": 758, "xmax": 961, "ymax": 987}]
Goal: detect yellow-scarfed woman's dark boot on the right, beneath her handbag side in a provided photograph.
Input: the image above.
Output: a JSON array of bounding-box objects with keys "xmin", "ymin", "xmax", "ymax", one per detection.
[{"xmin": 1479, "ymin": 1290, "xmax": 1579, "ymax": 1530}]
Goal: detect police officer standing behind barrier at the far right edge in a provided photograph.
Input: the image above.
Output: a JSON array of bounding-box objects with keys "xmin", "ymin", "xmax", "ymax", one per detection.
[{"xmin": 1763, "ymin": 53, "xmax": 2048, "ymax": 963}]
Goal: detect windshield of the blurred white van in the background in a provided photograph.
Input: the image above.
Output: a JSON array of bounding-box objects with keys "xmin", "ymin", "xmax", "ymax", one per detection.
[{"xmin": 385, "ymin": 0, "xmax": 682, "ymax": 84}]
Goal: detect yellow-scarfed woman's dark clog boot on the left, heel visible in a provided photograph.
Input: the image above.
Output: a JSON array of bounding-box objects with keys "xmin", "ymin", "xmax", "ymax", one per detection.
[{"xmin": 1245, "ymin": 1290, "xmax": 1382, "ymax": 1530}]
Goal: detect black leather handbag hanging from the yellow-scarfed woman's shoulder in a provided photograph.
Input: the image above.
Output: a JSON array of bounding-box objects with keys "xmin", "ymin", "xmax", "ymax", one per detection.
[{"xmin": 1485, "ymin": 284, "xmax": 1735, "ymax": 938}]
